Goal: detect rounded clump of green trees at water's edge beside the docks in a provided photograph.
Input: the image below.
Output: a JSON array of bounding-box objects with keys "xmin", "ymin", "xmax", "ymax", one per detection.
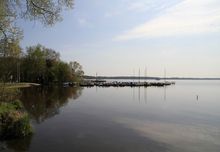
[{"xmin": 18, "ymin": 45, "xmax": 84, "ymax": 84}]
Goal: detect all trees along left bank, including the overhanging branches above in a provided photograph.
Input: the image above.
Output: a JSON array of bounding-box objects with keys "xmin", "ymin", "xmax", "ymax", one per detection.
[{"xmin": 0, "ymin": 0, "xmax": 83, "ymax": 84}]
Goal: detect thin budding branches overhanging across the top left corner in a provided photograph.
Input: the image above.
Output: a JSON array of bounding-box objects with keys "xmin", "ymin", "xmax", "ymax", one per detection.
[{"xmin": 0, "ymin": 0, "xmax": 73, "ymax": 25}]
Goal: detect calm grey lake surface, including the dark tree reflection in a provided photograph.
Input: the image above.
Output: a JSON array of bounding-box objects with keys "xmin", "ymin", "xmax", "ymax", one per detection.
[{"xmin": 0, "ymin": 81, "xmax": 220, "ymax": 152}]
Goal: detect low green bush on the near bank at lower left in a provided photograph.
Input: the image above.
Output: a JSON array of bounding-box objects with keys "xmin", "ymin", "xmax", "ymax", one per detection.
[{"xmin": 0, "ymin": 100, "xmax": 32, "ymax": 139}]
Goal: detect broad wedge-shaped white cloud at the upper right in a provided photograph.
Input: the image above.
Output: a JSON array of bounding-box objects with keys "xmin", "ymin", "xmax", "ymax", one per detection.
[{"xmin": 114, "ymin": 0, "xmax": 220, "ymax": 41}]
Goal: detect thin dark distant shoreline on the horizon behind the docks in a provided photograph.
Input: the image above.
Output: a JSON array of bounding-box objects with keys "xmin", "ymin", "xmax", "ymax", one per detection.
[{"xmin": 84, "ymin": 76, "xmax": 220, "ymax": 80}]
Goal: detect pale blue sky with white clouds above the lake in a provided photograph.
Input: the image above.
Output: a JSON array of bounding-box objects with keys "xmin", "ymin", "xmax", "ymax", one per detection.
[{"xmin": 19, "ymin": 0, "xmax": 220, "ymax": 77}]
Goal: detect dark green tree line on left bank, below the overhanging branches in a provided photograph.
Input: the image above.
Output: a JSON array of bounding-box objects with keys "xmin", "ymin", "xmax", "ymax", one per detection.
[{"xmin": 0, "ymin": 44, "xmax": 84, "ymax": 84}]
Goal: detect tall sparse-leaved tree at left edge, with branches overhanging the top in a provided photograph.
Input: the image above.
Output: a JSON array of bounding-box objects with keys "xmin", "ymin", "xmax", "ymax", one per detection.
[{"xmin": 0, "ymin": 0, "xmax": 74, "ymax": 81}]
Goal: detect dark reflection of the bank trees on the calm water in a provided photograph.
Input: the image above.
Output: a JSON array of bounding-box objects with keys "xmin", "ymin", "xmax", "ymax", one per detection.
[{"xmin": 21, "ymin": 87, "xmax": 82, "ymax": 123}]
